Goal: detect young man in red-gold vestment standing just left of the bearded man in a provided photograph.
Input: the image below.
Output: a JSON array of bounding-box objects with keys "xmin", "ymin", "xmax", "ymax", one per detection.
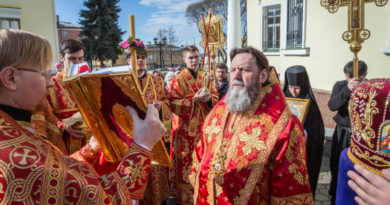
[{"xmin": 169, "ymin": 46, "xmax": 218, "ymax": 205}]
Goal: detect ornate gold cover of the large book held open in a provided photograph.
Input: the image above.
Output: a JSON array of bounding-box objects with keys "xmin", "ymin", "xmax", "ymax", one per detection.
[{"xmin": 64, "ymin": 69, "xmax": 171, "ymax": 166}]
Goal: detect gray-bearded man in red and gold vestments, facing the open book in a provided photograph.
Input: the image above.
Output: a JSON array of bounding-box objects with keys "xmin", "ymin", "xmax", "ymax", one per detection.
[{"xmin": 190, "ymin": 47, "xmax": 314, "ymax": 205}]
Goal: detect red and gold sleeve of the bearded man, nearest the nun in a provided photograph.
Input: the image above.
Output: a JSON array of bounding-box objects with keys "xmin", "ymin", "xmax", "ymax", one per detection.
[{"xmin": 270, "ymin": 117, "xmax": 314, "ymax": 204}]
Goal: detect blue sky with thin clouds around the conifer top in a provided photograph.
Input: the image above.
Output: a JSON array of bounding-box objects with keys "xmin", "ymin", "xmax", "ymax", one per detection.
[{"xmin": 55, "ymin": 0, "xmax": 201, "ymax": 47}]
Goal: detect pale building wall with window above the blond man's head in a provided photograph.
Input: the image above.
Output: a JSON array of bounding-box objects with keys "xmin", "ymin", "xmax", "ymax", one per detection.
[{"xmin": 0, "ymin": 0, "xmax": 58, "ymax": 62}]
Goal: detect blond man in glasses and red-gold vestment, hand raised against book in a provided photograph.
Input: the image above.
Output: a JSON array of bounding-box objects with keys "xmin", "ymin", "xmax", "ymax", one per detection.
[{"xmin": 0, "ymin": 29, "xmax": 166, "ymax": 204}]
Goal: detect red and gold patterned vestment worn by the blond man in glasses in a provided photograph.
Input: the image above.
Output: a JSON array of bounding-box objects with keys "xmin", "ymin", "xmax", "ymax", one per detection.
[{"xmin": 0, "ymin": 110, "xmax": 152, "ymax": 204}]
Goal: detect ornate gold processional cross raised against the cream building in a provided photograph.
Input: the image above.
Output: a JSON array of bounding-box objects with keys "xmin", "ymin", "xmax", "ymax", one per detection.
[{"xmin": 321, "ymin": 0, "xmax": 388, "ymax": 77}]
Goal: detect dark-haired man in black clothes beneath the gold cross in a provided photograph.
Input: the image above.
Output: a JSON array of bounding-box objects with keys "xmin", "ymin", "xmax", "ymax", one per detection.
[{"xmin": 328, "ymin": 61, "xmax": 367, "ymax": 204}]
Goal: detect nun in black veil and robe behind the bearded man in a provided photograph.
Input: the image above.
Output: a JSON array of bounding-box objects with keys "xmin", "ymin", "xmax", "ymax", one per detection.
[{"xmin": 283, "ymin": 65, "xmax": 325, "ymax": 197}]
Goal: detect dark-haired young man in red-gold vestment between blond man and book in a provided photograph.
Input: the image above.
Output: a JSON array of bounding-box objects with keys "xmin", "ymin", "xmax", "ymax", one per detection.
[{"xmin": 32, "ymin": 39, "xmax": 90, "ymax": 154}]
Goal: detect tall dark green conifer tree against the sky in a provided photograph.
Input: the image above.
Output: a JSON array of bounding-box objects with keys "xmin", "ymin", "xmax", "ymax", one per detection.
[{"xmin": 80, "ymin": 0, "xmax": 124, "ymax": 66}]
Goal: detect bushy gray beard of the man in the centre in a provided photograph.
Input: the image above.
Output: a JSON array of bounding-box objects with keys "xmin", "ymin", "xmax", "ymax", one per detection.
[{"xmin": 225, "ymin": 81, "xmax": 261, "ymax": 114}]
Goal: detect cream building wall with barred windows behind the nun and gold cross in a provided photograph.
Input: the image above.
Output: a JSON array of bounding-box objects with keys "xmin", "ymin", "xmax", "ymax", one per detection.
[{"xmin": 247, "ymin": 0, "xmax": 390, "ymax": 128}]
